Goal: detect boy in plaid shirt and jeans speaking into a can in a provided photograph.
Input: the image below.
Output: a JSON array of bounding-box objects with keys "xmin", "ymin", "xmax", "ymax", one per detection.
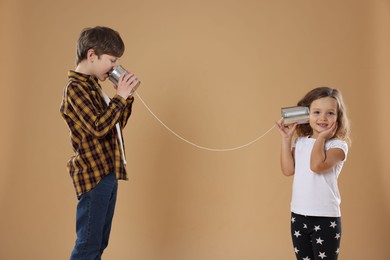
[{"xmin": 60, "ymin": 26, "xmax": 139, "ymax": 260}]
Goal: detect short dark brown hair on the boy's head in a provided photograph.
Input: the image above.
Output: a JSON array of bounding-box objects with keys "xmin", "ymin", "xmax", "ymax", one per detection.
[{"xmin": 76, "ymin": 26, "xmax": 125, "ymax": 65}]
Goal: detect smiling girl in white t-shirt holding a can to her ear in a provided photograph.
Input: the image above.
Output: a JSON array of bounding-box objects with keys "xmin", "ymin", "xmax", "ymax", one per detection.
[{"xmin": 276, "ymin": 87, "xmax": 350, "ymax": 260}]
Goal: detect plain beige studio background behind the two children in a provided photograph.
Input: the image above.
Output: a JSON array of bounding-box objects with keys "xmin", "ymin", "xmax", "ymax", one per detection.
[{"xmin": 0, "ymin": 0, "xmax": 390, "ymax": 260}]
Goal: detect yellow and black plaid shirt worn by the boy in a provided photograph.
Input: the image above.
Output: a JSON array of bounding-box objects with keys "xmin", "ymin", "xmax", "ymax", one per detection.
[{"xmin": 60, "ymin": 71, "xmax": 134, "ymax": 197}]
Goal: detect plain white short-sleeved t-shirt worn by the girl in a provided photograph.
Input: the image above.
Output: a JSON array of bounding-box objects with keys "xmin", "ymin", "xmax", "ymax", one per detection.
[{"xmin": 291, "ymin": 137, "xmax": 348, "ymax": 217}]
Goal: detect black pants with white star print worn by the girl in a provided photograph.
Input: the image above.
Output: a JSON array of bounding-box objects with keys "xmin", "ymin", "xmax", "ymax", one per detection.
[{"xmin": 291, "ymin": 213, "xmax": 341, "ymax": 260}]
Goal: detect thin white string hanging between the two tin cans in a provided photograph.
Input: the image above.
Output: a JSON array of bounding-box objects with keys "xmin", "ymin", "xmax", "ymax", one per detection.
[{"xmin": 135, "ymin": 91, "xmax": 275, "ymax": 152}]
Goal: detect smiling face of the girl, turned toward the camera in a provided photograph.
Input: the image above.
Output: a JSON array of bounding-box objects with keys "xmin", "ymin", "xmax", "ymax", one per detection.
[{"xmin": 309, "ymin": 97, "xmax": 337, "ymax": 138}]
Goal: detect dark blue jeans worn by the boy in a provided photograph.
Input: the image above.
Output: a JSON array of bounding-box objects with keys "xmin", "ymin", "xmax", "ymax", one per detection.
[{"xmin": 70, "ymin": 173, "xmax": 118, "ymax": 260}]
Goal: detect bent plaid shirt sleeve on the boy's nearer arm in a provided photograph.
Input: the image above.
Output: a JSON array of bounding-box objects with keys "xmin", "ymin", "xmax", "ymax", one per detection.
[{"xmin": 66, "ymin": 84, "xmax": 126, "ymax": 138}]
